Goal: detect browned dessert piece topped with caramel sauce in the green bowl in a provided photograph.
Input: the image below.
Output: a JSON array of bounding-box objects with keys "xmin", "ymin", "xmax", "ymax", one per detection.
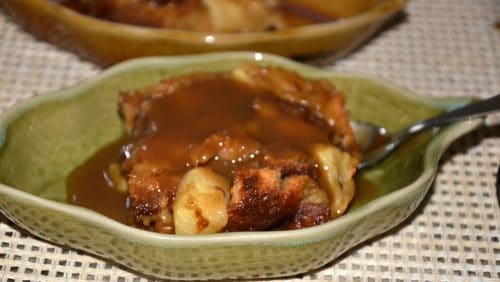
[{"xmin": 68, "ymin": 64, "xmax": 360, "ymax": 234}]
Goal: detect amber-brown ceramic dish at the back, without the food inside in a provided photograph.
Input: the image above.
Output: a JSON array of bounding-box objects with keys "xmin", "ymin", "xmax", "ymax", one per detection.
[{"xmin": 0, "ymin": 0, "xmax": 407, "ymax": 65}]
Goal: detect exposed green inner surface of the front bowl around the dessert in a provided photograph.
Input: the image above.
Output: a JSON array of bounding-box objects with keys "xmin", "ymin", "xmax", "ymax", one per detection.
[{"xmin": 0, "ymin": 53, "xmax": 466, "ymax": 216}]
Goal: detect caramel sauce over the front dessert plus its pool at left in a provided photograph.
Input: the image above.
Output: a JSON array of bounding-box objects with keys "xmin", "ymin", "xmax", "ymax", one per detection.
[{"xmin": 67, "ymin": 74, "xmax": 373, "ymax": 223}]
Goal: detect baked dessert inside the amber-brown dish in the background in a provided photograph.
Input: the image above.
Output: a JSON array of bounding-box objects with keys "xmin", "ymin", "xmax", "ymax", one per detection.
[{"xmin": 55, "ymin": 0, "xmax": 335, "ymax": 32}]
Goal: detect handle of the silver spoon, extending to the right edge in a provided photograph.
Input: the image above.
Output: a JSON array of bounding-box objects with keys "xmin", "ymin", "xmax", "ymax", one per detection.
[{"xmin": 405, "ymin": 94, "xmax": 500, "ymax": 134}]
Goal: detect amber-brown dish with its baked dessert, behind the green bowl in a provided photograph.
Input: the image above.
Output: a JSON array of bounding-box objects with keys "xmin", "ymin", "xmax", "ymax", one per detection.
[{"xmin": 0, "ymin": 0, "xmax": 406, "ymax": 66}]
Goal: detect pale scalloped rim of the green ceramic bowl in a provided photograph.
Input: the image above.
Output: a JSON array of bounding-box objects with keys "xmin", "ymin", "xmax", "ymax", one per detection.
[{"xmin": 0, "ymin": 52, "xmax": 483, "ymax": 248}]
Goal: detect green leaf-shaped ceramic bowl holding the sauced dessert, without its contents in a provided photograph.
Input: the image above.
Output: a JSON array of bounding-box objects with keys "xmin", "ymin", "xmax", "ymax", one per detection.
[{"xmin": 0, "ymin": 53, "xmax": 481, "ymax": 279}]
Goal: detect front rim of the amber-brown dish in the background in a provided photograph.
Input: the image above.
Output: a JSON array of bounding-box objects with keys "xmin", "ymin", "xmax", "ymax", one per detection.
[{"xmin": 47, "ymin": 0, "xmax": 408, "ymax": 45}]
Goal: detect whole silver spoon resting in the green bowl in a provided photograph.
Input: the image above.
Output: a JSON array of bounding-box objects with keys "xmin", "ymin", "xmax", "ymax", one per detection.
[{"xmin": 351, "ymin": 94, "xmax": 500, "ymax": 169}]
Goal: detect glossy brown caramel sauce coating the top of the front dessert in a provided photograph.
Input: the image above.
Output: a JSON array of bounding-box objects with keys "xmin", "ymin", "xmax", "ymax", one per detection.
[{"xmin": 124, "ymin": 75, "xmax": 332, "ymax": 178}]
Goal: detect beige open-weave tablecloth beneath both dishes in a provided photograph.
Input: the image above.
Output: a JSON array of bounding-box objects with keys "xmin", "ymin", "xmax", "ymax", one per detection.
[{"xmin": 0, "ymin": 0, "xmax": 500, "ymax": 281}]
